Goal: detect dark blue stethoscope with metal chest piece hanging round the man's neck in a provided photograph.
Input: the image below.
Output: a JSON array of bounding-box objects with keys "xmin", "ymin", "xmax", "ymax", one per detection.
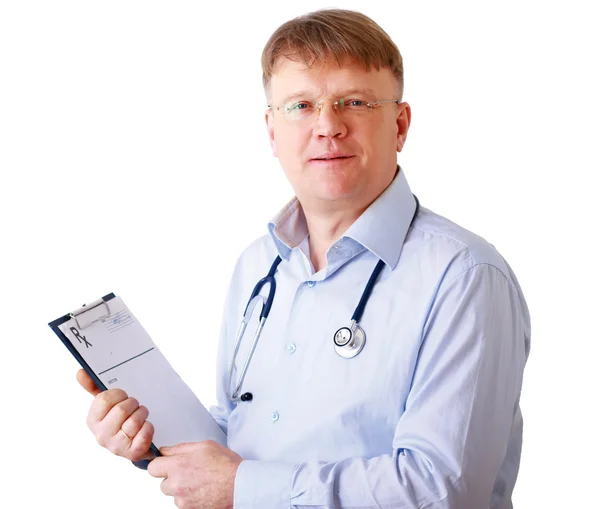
[{"xmin": 227, "ymin": 194, "xmax": 420, "ymax": 401}]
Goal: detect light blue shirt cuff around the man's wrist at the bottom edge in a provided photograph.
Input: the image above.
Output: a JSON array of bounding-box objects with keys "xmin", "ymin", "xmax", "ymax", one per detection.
[{"xmin": 233, "ymin": 460, "xmax": 296, "ymax": 509}]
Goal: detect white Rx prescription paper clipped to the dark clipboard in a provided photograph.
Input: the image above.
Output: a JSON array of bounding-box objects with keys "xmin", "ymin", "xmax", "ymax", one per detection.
[{"xmin": 59, "ymin": 297, "xmax": 227, "ymax": 448}]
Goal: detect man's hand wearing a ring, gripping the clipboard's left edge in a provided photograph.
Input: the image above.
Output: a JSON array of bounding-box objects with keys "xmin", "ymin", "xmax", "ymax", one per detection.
[{"xmin": 77, "ymin": 369, "xmax": 154, "ymax": 461}]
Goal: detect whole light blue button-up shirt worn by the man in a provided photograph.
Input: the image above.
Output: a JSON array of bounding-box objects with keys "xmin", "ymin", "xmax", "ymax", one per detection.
[{"xmin": 211, "ymin": 171, "xmax": 530, "ymax": 509}]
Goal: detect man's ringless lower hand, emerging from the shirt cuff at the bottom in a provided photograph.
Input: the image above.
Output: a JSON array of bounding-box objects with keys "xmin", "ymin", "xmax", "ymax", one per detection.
[{"xmin": 148, "ymin": 440, "xmax": 242, "ymax": 509}]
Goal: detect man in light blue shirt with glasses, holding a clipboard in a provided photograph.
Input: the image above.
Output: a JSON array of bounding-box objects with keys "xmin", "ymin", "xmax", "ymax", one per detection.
[{"xmin": 78, "ymin": 10, "xmax": 530, "ymax": 509}]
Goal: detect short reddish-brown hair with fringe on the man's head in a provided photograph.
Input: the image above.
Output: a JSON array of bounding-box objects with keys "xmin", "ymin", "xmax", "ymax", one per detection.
[{"xmin": 262, "ymin": 9, "xmax": 404, "ymax": 99}]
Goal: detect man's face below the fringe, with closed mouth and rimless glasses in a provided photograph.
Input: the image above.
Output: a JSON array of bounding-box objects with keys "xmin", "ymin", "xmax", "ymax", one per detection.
[{"xmin": 266, "ymin": 58, "xmax": 410, "ymax": 209}]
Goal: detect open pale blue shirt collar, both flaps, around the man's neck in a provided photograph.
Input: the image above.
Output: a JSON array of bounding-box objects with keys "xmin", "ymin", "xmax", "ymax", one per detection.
[{"xmin": 269, "ymin": 168, "xmax": 416, "ymax": 270}]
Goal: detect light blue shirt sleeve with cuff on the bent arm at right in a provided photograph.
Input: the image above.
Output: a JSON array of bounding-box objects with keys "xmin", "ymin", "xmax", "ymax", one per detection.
[{"xmin": 234, "ymin": 264, "xmax": 530, "ymax": 509}]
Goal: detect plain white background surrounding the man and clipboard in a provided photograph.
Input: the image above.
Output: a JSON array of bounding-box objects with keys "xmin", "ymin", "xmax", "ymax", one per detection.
[{"xmin": 0, "ymin": 0, "xmax": 600, "ymax": 509}]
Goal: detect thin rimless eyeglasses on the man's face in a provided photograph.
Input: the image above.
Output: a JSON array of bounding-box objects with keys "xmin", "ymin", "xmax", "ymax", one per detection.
[{"xmin": 268, "ymin": 98, "xmax": 400, "ymax": 122}]
